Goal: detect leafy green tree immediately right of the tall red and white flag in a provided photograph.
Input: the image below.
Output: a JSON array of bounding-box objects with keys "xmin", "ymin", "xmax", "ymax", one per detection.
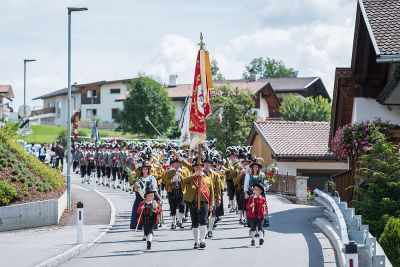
[{"xmin": 206, "ymin": 85, "xmax": 256, "ymax": 151}]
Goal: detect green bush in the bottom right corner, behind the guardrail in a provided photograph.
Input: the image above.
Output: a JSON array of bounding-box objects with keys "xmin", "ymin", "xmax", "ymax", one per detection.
[{"xmin": 379, "ymin": 218, "xmax": 400, "ymax": 267}]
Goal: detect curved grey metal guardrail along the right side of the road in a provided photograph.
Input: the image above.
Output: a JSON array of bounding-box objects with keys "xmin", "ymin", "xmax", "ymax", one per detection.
[{"xmin": 314, "ymin": 189, "xmax": 392, "ymax": 267}]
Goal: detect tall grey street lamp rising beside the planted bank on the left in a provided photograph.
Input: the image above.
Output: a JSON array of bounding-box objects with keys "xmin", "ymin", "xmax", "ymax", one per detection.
[{"xmin": 67, "ymin": 7, "xmax": 88, "ymax": 210}]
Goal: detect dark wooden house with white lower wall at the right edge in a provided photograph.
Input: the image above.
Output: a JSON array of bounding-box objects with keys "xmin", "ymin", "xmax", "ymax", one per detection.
[{"xmin": 330, "ymin": 0, "xmax": 400, "ymax": 201}]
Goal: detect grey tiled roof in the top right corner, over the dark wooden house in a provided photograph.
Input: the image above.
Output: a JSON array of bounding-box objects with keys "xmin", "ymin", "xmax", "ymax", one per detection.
[{"xmin": 358, "ymin": 0, "xmax": 400, "ymax": 62}]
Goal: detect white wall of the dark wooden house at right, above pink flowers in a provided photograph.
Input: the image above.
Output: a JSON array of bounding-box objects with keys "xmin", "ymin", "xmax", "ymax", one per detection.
[{"xmin": 351, "ymin": 97, "xmax": 400, "ymax": 124}]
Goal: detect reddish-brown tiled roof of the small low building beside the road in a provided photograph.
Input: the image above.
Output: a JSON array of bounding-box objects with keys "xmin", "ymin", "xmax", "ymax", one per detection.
[{"xmin": 247, "ymin": 120, "xmax": 336, "ymax": 159}]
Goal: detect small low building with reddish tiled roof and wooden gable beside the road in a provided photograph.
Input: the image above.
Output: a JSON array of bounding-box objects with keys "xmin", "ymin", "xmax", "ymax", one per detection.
[{"xmin": 247, "ymin": 120, "xmax": 348, "ymax": 192}]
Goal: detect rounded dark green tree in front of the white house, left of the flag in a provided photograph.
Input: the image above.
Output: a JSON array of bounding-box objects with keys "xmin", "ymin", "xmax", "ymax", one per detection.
[{"xmin": 116, "ymin": 75, "xmax": 175, "ymax": 137}]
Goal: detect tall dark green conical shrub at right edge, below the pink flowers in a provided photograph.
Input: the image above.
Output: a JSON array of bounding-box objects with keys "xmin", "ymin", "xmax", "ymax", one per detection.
[{"xmin": 354, "ymin": 132, "xmax": 400, "ymax": 239}]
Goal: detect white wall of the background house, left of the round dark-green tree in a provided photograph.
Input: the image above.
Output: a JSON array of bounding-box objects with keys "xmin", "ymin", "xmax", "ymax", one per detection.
[{"xmin": 81, "ymin": 83, "xmax": 127, "ymax": 122}]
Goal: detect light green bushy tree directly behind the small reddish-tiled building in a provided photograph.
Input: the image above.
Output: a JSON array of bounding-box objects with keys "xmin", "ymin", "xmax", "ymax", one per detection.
[{"xmin": 280, "ymin": 95, "xmax": 331, "ymax": 121}]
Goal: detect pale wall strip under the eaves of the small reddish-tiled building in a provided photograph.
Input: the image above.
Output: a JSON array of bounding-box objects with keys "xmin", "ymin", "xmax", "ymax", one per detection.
[{"xmin": 276, "ymin": 162, "xmax": 348, "ymax": 178}]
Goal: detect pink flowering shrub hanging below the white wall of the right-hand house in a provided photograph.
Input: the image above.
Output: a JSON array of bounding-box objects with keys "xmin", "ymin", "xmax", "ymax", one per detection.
[{"xmin": 331, "ymin": 118, "xmax": 395, "ymax": 158}]
